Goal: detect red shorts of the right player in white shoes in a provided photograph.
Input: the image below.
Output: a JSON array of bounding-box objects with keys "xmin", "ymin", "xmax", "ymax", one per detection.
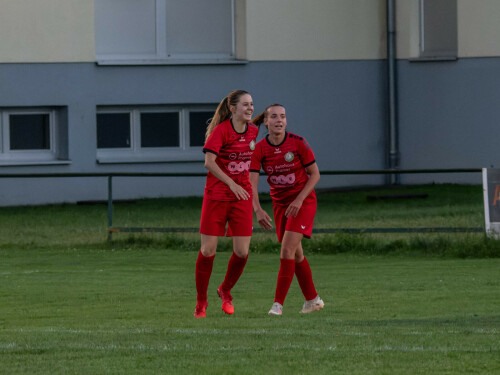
[{"xmin": 273, "ymin": 199, "xmax": 317, "ymax": 243}]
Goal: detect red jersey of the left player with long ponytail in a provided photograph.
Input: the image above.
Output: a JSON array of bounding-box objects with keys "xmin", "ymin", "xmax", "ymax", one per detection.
[{"xmin": 203, "ymin": 120, "xmax": 259, "ymax": 201}]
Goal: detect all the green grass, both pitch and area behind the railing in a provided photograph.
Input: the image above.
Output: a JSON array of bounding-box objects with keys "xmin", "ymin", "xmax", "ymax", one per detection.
[{"xmin": 0, "ymin": 185, "xmax": 500, "ymax": 374}]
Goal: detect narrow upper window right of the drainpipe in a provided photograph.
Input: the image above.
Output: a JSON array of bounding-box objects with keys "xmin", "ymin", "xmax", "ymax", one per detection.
[{"xmin": 419, "ymin": 0, "xmax": 458, "ymax": 59}]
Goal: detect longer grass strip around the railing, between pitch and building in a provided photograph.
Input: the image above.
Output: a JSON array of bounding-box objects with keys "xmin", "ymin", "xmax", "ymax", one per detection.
[{"xmin": 0, "ymin": 185, "xmax": 500, "ymax": 257}]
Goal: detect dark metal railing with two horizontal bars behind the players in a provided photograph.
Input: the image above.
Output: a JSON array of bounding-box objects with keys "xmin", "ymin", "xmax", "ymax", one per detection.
[{"xmin": 0, "ymin": 168, "xmax": 484, "ymax": 241}]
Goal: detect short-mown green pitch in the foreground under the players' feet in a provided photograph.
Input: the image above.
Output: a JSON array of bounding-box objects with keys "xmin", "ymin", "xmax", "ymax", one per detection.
[{"xmin": 0, "ymin": 249, "xmax": 500, "ymax": 374}]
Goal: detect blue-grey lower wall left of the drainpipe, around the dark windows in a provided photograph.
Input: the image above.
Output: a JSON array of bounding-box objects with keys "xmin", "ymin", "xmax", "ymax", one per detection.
[{"xmin": 0, "ymin": 60, "xmax": 385, "ymax": 205}]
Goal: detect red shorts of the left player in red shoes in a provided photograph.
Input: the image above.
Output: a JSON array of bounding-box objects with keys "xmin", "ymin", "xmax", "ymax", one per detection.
[{"xmin": 200, "ymin": 198, "xmax": 253, "ymax": 236}]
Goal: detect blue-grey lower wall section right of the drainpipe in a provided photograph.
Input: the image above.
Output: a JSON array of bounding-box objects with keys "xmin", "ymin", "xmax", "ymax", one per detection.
[{"xmin": 398, "ymin": 58, "xmax": 500, "ymax": 184}]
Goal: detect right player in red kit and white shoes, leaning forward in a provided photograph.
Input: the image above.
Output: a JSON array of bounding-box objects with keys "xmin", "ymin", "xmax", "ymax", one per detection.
[{"xmin": 250, "ymin": 104, "xmax": 324, "ymax": 315}]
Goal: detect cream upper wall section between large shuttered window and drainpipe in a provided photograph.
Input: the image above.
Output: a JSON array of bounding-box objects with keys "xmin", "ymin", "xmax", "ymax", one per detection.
[{"xmin": 246, "ymin": 0, "xmax": 386, "ymax": 61}]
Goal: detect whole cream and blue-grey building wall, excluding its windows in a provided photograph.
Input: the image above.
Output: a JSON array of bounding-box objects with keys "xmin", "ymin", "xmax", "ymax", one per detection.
[{"xmin": 0, "ymin": 0, "xmax": 500, "ymax": 205}]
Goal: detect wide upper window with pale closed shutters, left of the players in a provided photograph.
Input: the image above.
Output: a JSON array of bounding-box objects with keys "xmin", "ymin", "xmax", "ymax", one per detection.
[{"xmin": 95, "ymin": 0, "xmax": 234, "ymax": 63}]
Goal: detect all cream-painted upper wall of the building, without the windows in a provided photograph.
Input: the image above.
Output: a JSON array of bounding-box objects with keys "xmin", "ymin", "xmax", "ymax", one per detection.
[{"xmin": 0, "ymin": 0, "xmax": 500, "ymax": 63}]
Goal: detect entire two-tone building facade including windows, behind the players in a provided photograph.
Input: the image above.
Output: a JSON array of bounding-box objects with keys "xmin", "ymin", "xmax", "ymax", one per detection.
[{"xmin": 0, "ymin": 0, "xmax": 500, "ymax": 206}]
